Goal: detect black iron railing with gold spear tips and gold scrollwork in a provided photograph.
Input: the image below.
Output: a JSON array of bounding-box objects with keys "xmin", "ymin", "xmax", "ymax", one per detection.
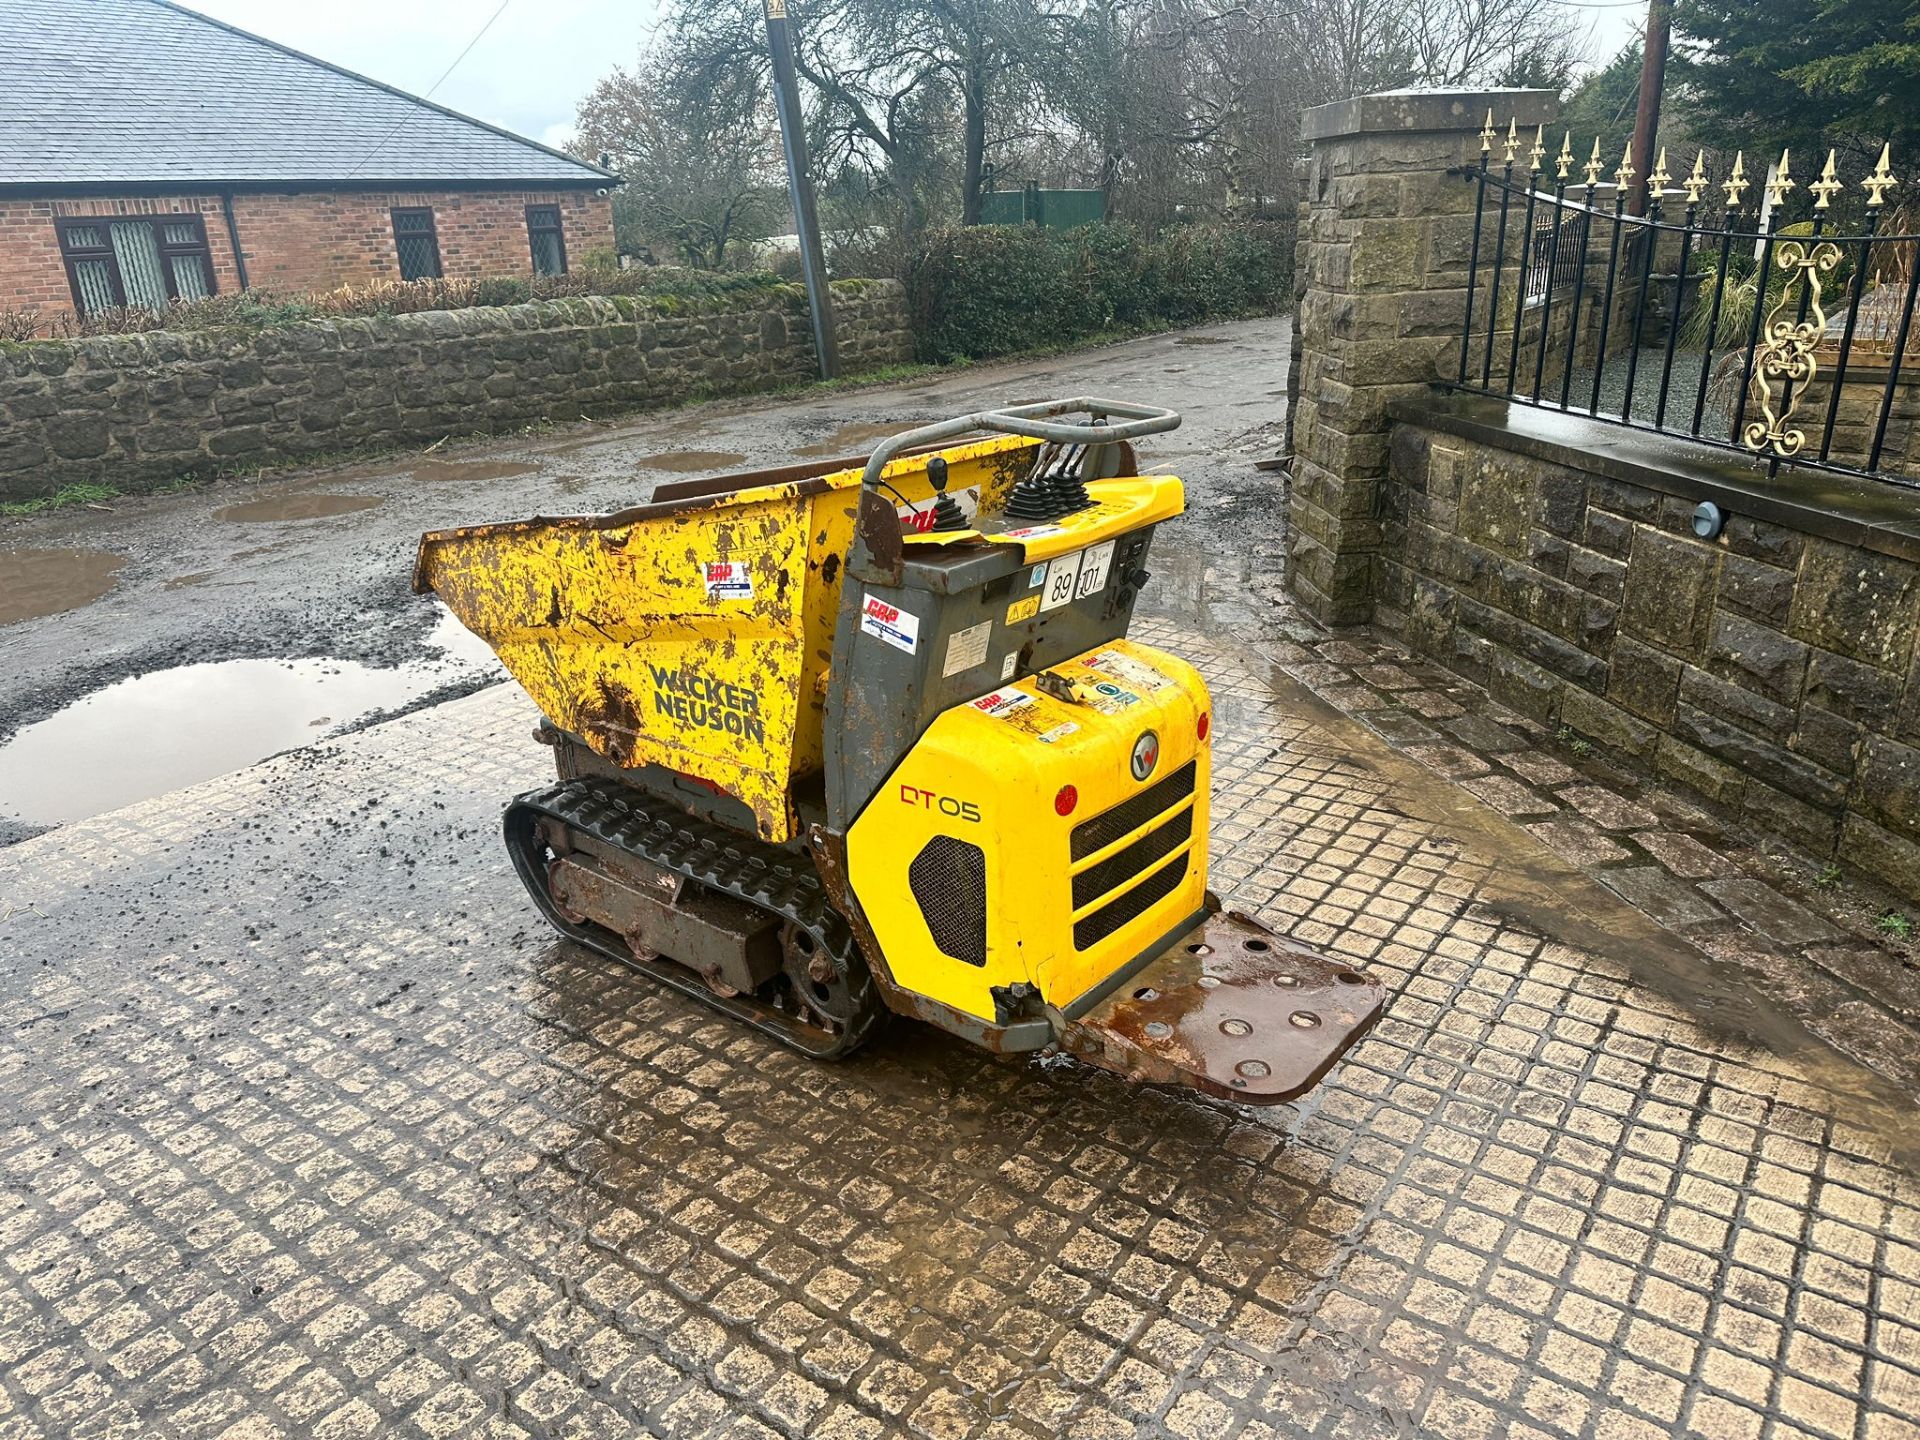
[{"xmin": 1455, "ymin": 117, "xmax": 1920, "ymax": 486}]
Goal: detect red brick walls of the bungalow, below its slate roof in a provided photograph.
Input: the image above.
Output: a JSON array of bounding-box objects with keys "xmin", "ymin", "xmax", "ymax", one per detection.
[{"xmin": 0, "ymin": 190, "xmax": 612, "ymax": 311}]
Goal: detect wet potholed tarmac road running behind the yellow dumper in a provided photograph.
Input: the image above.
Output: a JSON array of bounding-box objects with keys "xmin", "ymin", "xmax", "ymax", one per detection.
[{"xmin": 0, "ymin": 319, "xmax": 1290, "ymax": 845}]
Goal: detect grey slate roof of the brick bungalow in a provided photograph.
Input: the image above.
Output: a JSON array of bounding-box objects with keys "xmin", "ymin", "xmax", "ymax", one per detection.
[{"xmin": 0, "ymin": 0, "xmax": 616, "ymax": 192}]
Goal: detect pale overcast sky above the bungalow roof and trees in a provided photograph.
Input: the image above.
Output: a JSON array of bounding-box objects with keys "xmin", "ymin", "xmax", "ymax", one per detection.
[{"xmin": 184, "ymin": 0, "xmax": 1644, "ymax": 156}]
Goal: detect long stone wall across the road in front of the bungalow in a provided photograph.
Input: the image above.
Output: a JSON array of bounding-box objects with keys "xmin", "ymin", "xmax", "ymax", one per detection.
[{"xmin": 0, "ymin": 280, "xmax": 914, "ymax": 499}]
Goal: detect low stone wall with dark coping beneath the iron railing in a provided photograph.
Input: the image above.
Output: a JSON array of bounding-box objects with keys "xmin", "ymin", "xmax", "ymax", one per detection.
[{"xmin": 1375, "ymin": 399, "xmax": 1920, "ymax": 895}]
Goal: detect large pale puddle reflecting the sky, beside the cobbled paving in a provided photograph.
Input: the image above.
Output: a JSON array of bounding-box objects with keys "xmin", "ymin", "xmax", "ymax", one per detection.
[{"xmin": 0, "ymin": 612, "xmax": 497, "ymax": 826}]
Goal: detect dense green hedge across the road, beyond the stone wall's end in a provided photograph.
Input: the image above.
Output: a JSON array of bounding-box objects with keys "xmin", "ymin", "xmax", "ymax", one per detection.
[{"xmin": 906, "ymin": 221, "xmax": 1294, "ymax": 363}]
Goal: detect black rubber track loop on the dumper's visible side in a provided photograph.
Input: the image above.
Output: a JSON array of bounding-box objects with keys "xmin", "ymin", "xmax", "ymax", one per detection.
[{"xmin": 501, "ymin": 778, "xmax": 887, "ymax": 1060}]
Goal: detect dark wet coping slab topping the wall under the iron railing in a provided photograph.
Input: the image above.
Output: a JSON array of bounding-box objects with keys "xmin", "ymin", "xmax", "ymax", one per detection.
[{"xmin": 1386, "ymin": 390, "xmax": 1920, "ymax": 561}]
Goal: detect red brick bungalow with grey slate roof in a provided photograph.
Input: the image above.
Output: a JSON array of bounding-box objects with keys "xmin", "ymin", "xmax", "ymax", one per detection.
[{"xmin": 0, "ymin": 0, "xmax": 618, "ymax": 324}]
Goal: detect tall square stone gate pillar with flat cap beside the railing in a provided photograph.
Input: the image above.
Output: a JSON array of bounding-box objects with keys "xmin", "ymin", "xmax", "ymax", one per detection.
[{"xmin": 1286, "ymin": 90, "xmax": 1557, "ymax": 626}]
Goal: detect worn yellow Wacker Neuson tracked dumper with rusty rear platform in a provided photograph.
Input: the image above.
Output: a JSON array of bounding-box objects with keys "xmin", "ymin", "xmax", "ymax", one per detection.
[{"xmin": 413, "ymin": 399, "xmax": 1382, "ymax": 1104}]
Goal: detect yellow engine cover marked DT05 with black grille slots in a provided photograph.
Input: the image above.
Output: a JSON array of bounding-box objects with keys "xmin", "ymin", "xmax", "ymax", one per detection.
[{"xmin": 847, "ymin": 639, "xmax": 1210, "ymax": 1020}]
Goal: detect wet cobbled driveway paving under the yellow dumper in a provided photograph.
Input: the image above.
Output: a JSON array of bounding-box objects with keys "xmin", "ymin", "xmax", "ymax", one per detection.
[{"xmin": 0, "ymin": 622, "xmax": 1920, "ymax": 1440}]
